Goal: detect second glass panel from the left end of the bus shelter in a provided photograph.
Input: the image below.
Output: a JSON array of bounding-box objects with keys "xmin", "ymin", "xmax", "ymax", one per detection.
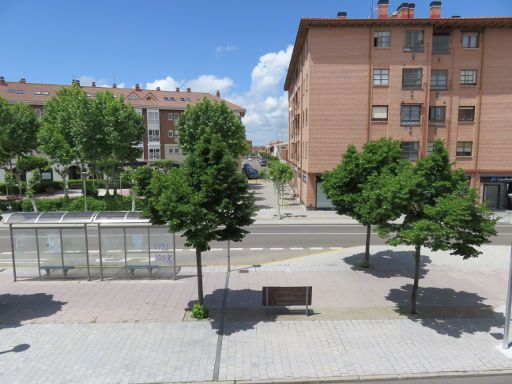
[{"xmin": 37, "ymin": 228, "xmax": 65, "ymax": 279}]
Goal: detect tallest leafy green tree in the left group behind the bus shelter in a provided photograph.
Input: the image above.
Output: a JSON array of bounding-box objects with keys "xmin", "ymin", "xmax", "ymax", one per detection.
[{"xmin": 39, "ymin": 84, "xmax": 89, "ymax": 198}]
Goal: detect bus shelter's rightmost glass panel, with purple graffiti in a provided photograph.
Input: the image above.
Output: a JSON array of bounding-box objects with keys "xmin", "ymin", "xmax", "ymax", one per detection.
[{"xmin": 149, "ymin": 226, "xmax": 174, "ymax": 279}]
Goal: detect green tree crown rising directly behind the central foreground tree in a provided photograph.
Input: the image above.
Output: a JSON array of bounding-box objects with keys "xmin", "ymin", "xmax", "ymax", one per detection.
[{"xmin": 178, "ymin": 97, "xmax": 248, "ymax": 159}]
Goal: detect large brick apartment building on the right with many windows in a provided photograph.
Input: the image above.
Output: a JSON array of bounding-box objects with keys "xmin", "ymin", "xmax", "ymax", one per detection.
[{"xmin": 285, "ymin": 0, "xmax": 512, "ymax": 209}]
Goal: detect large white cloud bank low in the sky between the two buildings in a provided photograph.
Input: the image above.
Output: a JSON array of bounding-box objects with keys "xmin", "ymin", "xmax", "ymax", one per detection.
[{"xmin": 146, "ymin": 45, "xmax": 293, "ymax": 145}]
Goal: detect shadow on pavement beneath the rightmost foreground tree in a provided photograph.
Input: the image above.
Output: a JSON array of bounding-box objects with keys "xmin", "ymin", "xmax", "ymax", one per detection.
[{"xmin": 386, "ymin": 281, "xmax": 505, "ymax": 338}]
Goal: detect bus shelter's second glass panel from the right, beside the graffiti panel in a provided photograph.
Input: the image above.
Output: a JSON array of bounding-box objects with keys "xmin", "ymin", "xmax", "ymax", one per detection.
[{"xmin": 125, "ymin": 227, "xmax": 150, "ymax": 277}]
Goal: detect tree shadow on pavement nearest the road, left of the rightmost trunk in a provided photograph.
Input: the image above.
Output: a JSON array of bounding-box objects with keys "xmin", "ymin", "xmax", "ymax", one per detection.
[{"xmin": 343, "ymin": 250, "xmax": 432, "ymax": 279}]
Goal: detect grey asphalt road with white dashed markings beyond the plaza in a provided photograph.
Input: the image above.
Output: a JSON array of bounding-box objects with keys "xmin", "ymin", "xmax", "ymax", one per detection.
[{"xmin": 0, "ymin": 224, "xmax": 512, "ymax": 265}]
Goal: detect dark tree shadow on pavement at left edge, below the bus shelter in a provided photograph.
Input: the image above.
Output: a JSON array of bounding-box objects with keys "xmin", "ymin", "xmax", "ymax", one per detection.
[{"xmin": 0, "ymin": 293, "xmax": 66, "ymax": 329}]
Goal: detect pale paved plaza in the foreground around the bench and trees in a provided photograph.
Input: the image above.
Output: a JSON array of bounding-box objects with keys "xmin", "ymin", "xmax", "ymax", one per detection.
[{"xmin": 0, "ymin": 246, "xmax": 512, "ymax": 384}]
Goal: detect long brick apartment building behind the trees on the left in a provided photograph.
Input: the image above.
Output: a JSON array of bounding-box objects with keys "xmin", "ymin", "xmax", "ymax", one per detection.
[{"xmin": 0, "ymin": 77, "xmax": 245, "ymax": 179}]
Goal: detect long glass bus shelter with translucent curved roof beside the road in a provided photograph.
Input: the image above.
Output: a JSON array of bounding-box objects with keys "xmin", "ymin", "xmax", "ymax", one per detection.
[{"xmin": 4, "ymin": 212, "xmax": 177, "ymax": 281}]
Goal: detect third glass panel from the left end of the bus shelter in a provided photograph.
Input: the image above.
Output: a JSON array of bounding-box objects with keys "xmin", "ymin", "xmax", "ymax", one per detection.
[{"xmin": 62, "ymin": 227, "xmax": 87, "ymax": 279}]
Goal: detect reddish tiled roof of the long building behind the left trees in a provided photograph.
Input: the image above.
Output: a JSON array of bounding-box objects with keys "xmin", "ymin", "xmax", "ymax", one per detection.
[{"xmin": 0, "ymin": 80, "xmax": 245, "ymax": 115}]
